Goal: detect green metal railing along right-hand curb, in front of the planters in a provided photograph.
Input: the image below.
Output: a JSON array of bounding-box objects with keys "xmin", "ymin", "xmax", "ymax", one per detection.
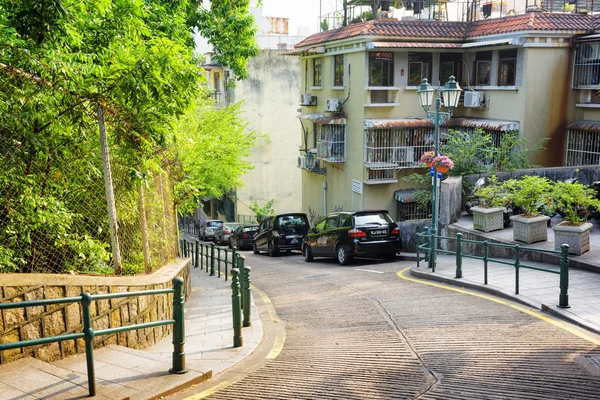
[{"xmin": 417, "ymin": 227, "xmax": 570, "ymax": 308}]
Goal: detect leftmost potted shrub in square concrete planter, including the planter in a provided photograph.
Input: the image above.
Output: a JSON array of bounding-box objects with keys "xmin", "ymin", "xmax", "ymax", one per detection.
[{"xmin": 470, "ymin": 175, "xmax": 506, "ymax": 232}]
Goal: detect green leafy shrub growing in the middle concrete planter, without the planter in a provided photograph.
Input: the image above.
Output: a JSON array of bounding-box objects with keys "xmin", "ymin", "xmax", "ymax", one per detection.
[{"xmin": 503, "ymin": 176, "xmax": 554, "ymax": 216}]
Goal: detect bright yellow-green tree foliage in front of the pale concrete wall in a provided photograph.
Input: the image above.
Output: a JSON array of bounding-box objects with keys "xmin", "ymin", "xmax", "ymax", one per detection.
[{"xmin": 175, "ymin": 100, "xmax": 259, "ymax": 215}]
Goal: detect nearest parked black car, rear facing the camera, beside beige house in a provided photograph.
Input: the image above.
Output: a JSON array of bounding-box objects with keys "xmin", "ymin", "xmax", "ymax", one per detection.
[{"xmin": 302, "ymin": 210, "xmax": 401, "ymax": 265}]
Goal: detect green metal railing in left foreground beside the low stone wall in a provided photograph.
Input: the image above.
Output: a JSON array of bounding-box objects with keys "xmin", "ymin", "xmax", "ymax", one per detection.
[{"xmin": 0, "ymin": 277, "xmax": 188, "ymax": 396}]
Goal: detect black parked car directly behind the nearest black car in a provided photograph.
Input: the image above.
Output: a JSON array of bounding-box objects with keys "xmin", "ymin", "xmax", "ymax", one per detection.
[{"xmin": 253, "ymin": 213, "xmax": 309, "ymax": 257}]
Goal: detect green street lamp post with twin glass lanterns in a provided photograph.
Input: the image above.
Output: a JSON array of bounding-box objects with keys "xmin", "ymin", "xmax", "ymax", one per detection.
[{"xmin": 417, "ymin": 76, "xmax": 462, "ymax": 271}]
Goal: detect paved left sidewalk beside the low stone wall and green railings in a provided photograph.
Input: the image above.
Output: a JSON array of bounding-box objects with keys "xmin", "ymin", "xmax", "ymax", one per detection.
[{"xmin": 0, "ymin": 255, "xmax": 263, "ymax": 400}]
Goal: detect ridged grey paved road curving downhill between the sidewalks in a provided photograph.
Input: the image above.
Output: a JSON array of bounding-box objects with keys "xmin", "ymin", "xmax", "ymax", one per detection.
[{"xmin": 182, "ymin": 248, "xmax": 600, "ymax": 399}]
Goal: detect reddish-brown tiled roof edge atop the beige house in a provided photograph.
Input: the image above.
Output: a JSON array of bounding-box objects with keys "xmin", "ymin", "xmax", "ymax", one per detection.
[{"xmin": 295, "ymin": 12, "xmax": 600, "ymax": 48}]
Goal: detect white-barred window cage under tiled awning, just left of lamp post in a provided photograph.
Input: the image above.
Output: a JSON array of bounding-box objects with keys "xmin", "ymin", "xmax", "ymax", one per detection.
[{"xmin": 364, "ymin": 127, "xmax": 434, "ymax": 170}]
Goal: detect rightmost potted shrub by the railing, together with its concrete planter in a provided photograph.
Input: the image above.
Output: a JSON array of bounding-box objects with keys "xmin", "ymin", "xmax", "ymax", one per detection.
[{"xmin": 552, "ymin": 182, "xmax": 600, "ymax": 255}]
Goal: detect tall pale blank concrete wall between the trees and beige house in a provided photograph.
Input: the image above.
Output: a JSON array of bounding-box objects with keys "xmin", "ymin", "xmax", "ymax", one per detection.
[{"xmin": 235, "ymin": 50, "xmax": 302, "ymax": 219}]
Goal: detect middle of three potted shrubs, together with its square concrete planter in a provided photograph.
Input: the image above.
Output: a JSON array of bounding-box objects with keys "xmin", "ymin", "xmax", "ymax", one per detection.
[{"xmin": 503, "ymin": 176, "xmax": 553, "ymax": 244}]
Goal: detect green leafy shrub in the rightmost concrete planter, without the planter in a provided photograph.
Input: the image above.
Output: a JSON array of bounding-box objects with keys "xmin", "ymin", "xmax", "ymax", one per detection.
[{"xmin": 550, "ymin": 182, "xmax": 600, "ymax": 224}]
